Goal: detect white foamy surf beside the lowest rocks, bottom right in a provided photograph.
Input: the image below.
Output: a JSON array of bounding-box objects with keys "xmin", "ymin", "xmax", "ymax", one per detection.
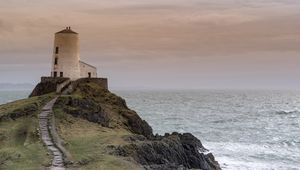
[{"xmin": 203, "ymin": 142, "xmax": 300, "ymax": 170}]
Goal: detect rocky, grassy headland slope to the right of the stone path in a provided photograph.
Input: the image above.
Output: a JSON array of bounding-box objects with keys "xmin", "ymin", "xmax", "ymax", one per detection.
[{"xmin": 0, "ymin": 82, "xmax": 220, "ymax": 170}]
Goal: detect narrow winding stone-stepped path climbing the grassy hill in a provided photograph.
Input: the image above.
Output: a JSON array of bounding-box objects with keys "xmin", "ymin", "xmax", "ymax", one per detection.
[{"xmin": 39, "ymin": 97, "xmax": 65, "ymax": 170}]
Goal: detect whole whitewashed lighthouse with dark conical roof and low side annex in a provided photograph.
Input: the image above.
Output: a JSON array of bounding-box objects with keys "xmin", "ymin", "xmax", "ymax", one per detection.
[{"xmin": 51, "ymin": 27, "xmax": 97, "ymax": 80}]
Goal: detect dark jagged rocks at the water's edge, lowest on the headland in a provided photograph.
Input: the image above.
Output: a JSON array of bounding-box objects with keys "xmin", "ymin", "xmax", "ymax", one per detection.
[{"xmin": 113, "ymin": 133, "xmax": 220, "ymax": 170}]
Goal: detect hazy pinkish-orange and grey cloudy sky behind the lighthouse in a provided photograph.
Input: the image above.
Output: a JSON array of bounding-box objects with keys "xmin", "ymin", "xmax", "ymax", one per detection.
[{"xmin": 0, "ymin": 0, "xmax": 300, "ymax": 89}]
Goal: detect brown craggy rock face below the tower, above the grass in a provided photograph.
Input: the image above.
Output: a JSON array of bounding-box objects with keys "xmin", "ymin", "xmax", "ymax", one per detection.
[{"xmin": 55, "ymin": 86, "xmax": 153, "ymax": 138}]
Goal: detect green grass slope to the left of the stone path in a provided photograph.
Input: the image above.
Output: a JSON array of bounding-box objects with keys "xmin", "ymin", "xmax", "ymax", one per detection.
[{"xmin": 0, "ymin": 94, "xmax": 53, "ymax": 170}]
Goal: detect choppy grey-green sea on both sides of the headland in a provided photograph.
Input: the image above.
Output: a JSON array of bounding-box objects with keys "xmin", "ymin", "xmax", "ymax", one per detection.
[{"xmin": 0, "ymin": 90, "xmax": 300, "ymax": 170}]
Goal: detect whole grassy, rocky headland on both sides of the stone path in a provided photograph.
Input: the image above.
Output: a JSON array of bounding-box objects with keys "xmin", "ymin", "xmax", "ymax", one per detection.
[{"xmin": 0, "ymin": 82, "xmax": 220, "ymax": 170}]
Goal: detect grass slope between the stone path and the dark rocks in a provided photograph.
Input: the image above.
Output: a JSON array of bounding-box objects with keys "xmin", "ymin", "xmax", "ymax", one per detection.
[{"xmin": 55, "ymin": 109, "xmax": 142, "ymax": 170}]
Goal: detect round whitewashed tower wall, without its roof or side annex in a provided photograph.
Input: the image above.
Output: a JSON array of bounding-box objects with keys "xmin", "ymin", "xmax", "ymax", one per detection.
[{"xmin": 51, "ymin": 33, "xmax": 80, "ymax": 80}]
